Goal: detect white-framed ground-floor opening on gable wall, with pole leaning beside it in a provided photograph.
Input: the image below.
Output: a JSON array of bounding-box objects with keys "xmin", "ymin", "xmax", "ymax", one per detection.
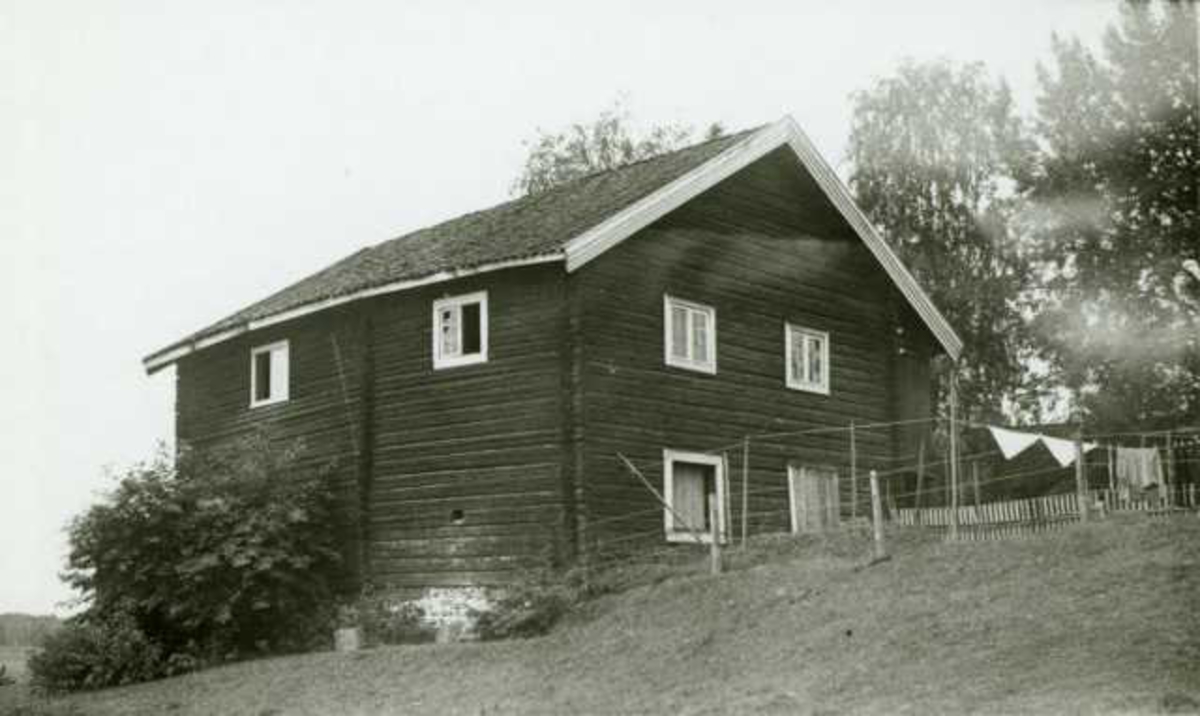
[{"xmin": 662, "ymin": 450, "xmax": 726, "ymax": 543}]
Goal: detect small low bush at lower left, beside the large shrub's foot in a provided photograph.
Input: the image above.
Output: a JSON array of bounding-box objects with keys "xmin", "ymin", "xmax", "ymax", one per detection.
[{"xmin": 29, "ymin": 606, "xmax": 164, "ymax": 693}]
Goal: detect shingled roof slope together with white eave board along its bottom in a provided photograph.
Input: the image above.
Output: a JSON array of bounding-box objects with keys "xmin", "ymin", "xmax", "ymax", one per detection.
[{"xmin": 143, "ymin": 122, "xmax": 854, "ymax": 373}]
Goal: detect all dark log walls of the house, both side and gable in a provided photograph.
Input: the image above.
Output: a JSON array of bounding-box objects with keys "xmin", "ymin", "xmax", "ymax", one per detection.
[{"xmin": 176, "ymin": 146, "xmax": 934, "ymax": 589}]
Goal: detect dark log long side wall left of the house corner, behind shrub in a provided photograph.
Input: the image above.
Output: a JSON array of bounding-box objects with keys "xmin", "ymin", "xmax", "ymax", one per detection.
[{"xmin": 176, "ymin": 265, "xmax": 568, "ymax": 588}]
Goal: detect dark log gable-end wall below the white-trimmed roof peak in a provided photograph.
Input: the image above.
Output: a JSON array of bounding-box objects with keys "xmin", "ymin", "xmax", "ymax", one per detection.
[{"xmin": 572, "ymin": 146, "xmax": 932, "ymax": 548}]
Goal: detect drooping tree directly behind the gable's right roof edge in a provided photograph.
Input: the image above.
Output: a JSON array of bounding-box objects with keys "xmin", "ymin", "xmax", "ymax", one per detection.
[{"xmin": 848, "ymin": 61, "xmax": 1033, "ymax": 417}]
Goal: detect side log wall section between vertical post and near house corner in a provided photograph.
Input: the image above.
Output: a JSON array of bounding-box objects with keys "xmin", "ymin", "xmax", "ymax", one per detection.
[{"xmin": 371, "ymin": 264, "xmax": 565, "ymax": 586}]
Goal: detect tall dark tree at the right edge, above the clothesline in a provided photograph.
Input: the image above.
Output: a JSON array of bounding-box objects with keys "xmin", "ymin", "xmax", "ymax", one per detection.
[{"xmin": 1022, "ymin": 2, "xmax": 1200, "ymax": 427}]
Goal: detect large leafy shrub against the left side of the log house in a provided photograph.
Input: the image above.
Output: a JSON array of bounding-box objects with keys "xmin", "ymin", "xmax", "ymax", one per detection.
[{"xmin": 35, "ymin": 435, "xmax": 338, "ymax": 686}]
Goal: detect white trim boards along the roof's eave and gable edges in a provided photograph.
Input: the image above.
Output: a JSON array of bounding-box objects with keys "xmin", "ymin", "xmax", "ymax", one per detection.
[{"xmin": 143, "ymin": 116, "xmax": 962, "ymax": 373}]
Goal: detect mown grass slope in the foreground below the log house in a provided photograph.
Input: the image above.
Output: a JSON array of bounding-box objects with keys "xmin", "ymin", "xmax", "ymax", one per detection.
[{"xmin": 0, "ymin": 516, "xmax": 1200, "ymax": 715}]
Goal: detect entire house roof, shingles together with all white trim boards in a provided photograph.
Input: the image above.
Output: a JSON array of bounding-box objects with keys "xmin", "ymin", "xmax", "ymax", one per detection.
[{"xmin": 143, "ymin": 116, "xmax": 962, "ymax": 373}]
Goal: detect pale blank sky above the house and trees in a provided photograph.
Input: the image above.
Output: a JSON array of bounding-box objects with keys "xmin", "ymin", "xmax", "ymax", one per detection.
[{"xmin": 0, "ymin": 0, "xmax": 1116, "ymax": 612}]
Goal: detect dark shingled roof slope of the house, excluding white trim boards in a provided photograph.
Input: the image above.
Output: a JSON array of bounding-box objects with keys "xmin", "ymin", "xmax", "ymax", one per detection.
[{"xmin": 181, "ymin": 130, "xmax": 754, "ymax": 350}]
